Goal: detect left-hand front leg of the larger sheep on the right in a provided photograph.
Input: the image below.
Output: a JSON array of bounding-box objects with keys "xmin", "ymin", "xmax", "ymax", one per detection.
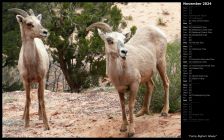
[{"xmin": 119, "ymin": 92, "xmax": 128, "ymax": 132}]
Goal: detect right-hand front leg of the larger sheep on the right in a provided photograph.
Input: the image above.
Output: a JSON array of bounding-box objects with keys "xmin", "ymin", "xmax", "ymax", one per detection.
[{"xmin": 128, "ymin": 82, "xmax": 139, "ymax": 137}]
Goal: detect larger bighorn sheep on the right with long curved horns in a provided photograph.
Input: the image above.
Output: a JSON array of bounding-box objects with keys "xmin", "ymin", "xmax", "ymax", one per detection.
[{"xmin": 86, "ymin": 22, "xmax": 169, "ymax": 136}]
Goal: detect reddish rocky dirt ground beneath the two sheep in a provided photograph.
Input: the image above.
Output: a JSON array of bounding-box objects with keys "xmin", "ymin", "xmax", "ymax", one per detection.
[{"xmin": 3, "ymin": 88, "xmax": 181, "ymax": 137}]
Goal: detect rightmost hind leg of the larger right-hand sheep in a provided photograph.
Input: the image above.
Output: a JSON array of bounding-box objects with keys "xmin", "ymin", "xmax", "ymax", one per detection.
[{"xmin": 157, "ymin": 60, "xmax": 169, "ymax": 116}]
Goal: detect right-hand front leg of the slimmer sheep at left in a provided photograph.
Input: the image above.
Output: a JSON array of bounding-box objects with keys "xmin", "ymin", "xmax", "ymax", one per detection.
[{"xmin": 38, "ymin": 80, "xmax": 50, "ymax": 130}]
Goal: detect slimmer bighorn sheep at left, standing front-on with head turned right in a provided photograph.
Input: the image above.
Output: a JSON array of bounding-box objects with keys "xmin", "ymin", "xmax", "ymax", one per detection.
[{"xmin": 9, "ymin": 8, "xmax": 50, "ymax": 130}]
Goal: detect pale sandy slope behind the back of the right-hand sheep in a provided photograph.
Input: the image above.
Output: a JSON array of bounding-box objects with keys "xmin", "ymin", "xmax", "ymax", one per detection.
[{"xmin": 116, "ymin": 2, "xmax": 181, "ymax": 42}]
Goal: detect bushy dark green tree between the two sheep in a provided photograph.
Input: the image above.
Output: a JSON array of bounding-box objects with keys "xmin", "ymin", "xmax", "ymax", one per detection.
[{"xmin": 46, "ymin": 3, "xmax": 122, "ymax": 92}]
